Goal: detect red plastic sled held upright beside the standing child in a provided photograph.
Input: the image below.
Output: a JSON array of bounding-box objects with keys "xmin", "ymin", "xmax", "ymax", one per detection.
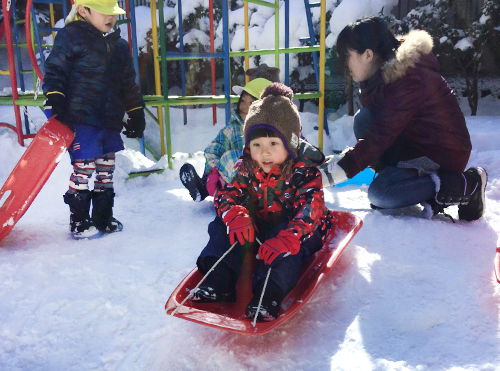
[{"xmin": 0, "ymin": 117, "xmax": 74, "ymax": 241}]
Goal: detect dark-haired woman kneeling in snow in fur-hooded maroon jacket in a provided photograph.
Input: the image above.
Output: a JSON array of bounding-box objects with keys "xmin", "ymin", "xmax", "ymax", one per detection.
[{"xmin": 321, "ymin": 16, "xmax": 488, "ymax": 221}]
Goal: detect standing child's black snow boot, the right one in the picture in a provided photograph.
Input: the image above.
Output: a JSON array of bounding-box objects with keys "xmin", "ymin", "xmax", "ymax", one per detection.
[{"xmin": 92, "ymin": 189, "xmax": 123, "ymax": 233}]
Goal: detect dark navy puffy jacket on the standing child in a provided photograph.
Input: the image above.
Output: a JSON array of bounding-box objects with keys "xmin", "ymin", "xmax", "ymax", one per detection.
[{"xmin": 43, "ymin": 21, "xmax": 144, "ymax": 131}]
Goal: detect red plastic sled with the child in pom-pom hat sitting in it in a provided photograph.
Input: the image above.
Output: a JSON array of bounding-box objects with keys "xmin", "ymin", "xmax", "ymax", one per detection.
[{"xmin": 165, "ymin": 211, "xmax": 363, "ymax": 335}]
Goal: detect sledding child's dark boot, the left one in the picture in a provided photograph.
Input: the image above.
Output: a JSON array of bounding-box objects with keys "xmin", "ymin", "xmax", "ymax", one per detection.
[{"xmin": 191, "ymin": 262, "xmax": 238, "ymax": 303}]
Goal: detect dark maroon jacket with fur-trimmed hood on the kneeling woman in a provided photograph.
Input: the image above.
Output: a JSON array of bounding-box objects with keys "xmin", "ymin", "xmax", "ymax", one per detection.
[{"xmin": 339, "ymin": 30, "xmax": 472, "ymax": 178}]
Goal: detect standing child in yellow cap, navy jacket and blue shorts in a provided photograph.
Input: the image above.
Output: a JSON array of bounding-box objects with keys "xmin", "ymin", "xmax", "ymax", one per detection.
[{"xmin": 43, "ymin": 0, "xmax": 146, "ymax": 238}]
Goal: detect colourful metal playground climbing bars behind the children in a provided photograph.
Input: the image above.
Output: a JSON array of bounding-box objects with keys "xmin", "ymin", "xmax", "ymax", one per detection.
[{"xmin": 0, "ymin": 0, "xmax": 327, "ymax": 168}]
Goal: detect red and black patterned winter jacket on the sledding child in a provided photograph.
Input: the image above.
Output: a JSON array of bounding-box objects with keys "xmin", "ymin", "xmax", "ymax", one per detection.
[{"xmin": 214, "ymin": 141, "xmax": 333, "ymax": 246}]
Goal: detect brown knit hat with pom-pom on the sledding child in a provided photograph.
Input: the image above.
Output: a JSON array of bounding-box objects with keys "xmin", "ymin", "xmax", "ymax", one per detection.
[{"xmin": 243, "ymin": 83, "xmax": 302, "ymax": 160}]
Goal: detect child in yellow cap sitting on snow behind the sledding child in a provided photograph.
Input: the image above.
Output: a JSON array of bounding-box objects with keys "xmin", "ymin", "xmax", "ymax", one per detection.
[{"xmin": 180, "ymin": 78, "xmax": 271, "ymax": 201}]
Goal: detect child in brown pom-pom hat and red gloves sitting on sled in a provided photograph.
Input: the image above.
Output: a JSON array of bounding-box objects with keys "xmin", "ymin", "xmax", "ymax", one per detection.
[{"xmin": 192, "ymin": 83, "xmax": 332, "ymax": 321}]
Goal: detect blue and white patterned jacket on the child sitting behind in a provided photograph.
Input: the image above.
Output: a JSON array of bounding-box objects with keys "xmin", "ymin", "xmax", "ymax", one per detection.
[{"xmin": 204, "ymin": 110, "xmax": 245, "ymax": 183}]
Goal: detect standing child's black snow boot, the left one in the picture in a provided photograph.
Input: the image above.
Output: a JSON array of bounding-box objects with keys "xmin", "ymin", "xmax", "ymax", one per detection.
[{"xmin": 63, "ymin": 190, "xmax": 99, "ymax": 238}]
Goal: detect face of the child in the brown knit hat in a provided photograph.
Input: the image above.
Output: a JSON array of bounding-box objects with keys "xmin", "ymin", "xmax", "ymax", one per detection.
[{"xmin": 250, "ymin": 137, "xmax": 288, "ymax": 173}]
